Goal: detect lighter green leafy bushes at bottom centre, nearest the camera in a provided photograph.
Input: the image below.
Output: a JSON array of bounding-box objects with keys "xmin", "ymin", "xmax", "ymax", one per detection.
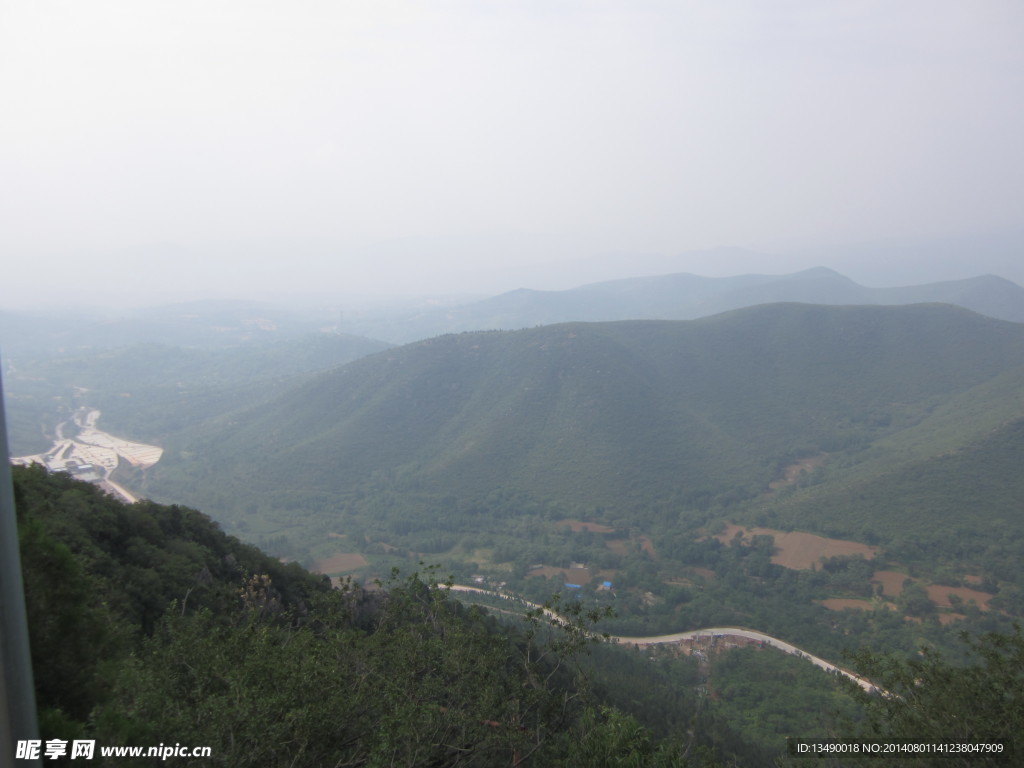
[{"xmin": 94, "ymin": 574, "xmax": 685, "ymax": 768}]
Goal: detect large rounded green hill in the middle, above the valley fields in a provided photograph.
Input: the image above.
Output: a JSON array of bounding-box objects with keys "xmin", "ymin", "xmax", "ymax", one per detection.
[{"xmin": 144, "ymin": 304, "xmax": 1024, "ymax": 557}]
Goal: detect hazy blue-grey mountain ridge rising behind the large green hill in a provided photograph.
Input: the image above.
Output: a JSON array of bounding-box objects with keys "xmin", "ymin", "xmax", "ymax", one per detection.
[{"xmin": 364, "ymin": 267, "xmax": 1024, "ymax": 342}]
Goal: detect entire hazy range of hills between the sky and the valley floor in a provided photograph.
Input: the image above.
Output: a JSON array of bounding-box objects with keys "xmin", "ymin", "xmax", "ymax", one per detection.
[{"xmin": 5, "ymin": 268, "xmax": 1024, "ymax": 593}]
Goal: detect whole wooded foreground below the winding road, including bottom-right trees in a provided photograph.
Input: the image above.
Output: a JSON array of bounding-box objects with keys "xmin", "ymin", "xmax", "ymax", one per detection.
[{"xmin": 13, "ymin": 467, "xmax": 1024, "ymax": 768}]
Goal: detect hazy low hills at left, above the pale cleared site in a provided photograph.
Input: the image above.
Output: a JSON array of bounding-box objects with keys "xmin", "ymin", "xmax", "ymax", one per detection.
[{"xmin": 4, "ymin": 325, "xmax": 390, "ymax": 456}]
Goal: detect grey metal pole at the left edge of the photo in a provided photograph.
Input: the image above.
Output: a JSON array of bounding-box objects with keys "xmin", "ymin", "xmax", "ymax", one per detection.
[{"xmin": 0, "ymin": 364, "xmax": 39, "ymax": 768}]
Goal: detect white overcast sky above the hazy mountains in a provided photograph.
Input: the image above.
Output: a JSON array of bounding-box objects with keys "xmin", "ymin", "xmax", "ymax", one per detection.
[{"xmin": 0, "ymin": 0, "xmax": 1024, "ymax": 307}]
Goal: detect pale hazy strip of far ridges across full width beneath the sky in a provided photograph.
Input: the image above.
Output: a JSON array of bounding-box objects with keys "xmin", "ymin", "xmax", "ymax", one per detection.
[{"xmin": 8, "ymin": 267, "xmax": 1024, "ymax": 359}]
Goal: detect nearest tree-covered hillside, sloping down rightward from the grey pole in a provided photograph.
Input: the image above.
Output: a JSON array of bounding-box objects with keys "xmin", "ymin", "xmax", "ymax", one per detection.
[{"xmin": 14, "ymin": 467, "xmax": 711, "ymax": 767}]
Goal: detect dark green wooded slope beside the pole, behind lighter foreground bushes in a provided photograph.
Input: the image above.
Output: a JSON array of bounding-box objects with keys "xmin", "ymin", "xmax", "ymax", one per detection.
[{"xmin": 13, "ymin": 467, "xmax": 326, "ymax": 727}]
